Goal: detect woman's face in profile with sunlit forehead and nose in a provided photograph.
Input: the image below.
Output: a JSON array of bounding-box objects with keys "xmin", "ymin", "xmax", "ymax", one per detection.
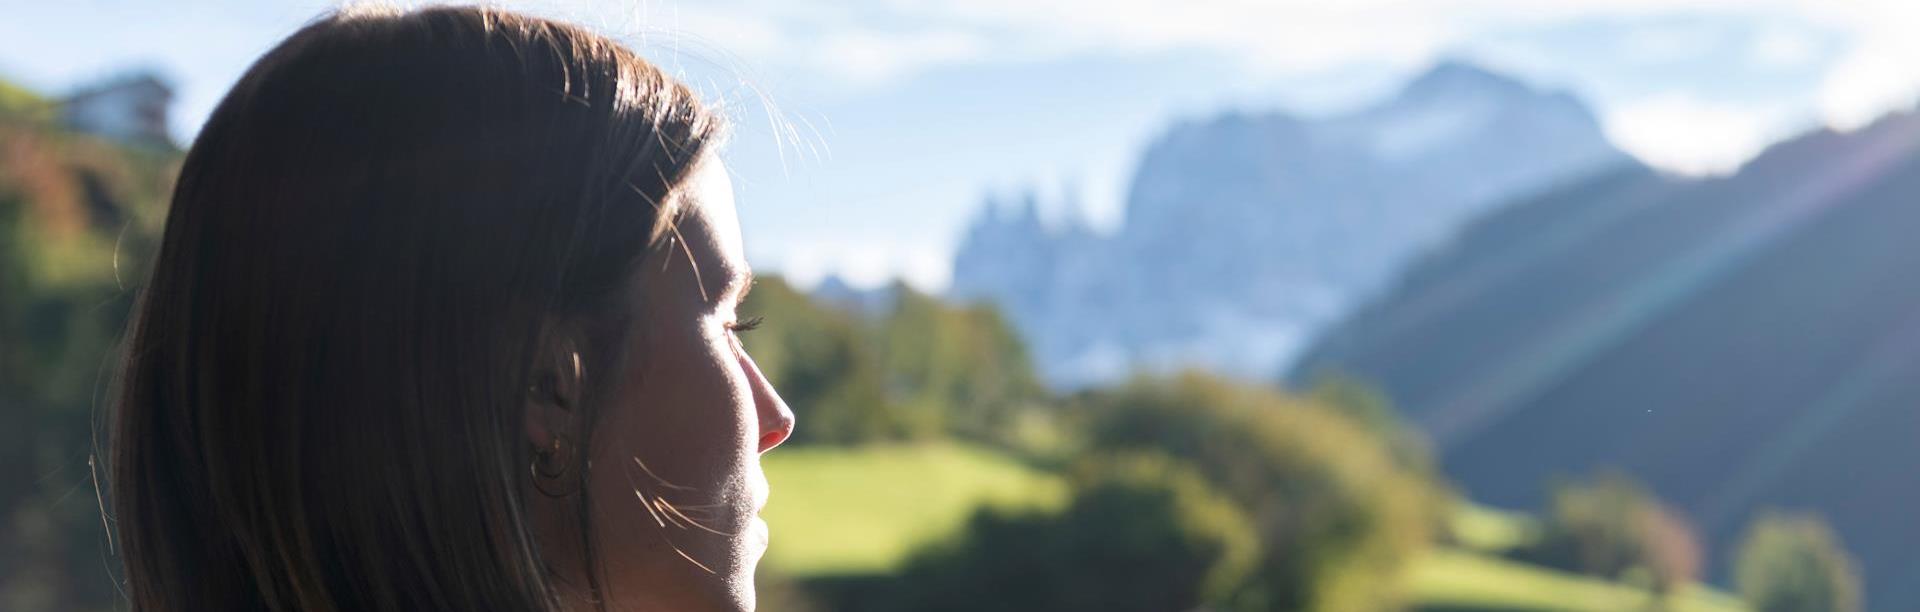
[{"xmin": 533, "ymin": 157, "xmax": 793, "ymax": 610}]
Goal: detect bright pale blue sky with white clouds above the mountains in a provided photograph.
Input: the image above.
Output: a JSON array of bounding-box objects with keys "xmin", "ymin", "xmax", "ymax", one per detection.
[{"xmin": 0, "ymin": 0, "xmax": 1920, "ymax": 290}]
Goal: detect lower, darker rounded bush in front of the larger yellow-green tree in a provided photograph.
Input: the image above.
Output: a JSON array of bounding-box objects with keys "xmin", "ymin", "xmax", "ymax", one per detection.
[{"xmin": 885, "ymin": 455, "xmax": 1258, "ymax": 612}]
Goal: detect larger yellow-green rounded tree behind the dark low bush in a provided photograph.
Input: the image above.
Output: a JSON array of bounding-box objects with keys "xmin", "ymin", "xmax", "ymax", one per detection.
[{"xmin": 1077, "ymin": 374, "xmax": 1438, "ymax": 610}]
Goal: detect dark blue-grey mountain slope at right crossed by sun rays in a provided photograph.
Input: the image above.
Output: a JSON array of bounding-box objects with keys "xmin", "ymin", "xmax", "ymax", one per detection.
[{"xmin": 1294, "ymin": 109, "xmax": 1920, "ymax": 610}]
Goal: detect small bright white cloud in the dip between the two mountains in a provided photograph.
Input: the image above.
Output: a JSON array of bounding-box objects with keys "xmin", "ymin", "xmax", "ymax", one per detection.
[{"xmin": 1603, "ymin": 94, "xmax": 1784, "ymax": 175}]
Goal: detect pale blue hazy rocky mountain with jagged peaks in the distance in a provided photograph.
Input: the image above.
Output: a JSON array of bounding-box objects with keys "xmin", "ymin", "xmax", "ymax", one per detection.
[{"xmin": 952, "ymin": 63, "xmax": 1624, "ymax": 388}]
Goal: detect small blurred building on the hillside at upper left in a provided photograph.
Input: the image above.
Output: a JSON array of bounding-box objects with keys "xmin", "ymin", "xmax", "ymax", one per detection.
[{"xmin": 60, "ymin": 71, "xmax": 173, "ymax": 146}]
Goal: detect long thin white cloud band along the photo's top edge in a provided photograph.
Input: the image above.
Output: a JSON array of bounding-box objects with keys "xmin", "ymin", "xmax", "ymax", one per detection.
[{"xmin": 618, "ymin": 0, "xmax": 1766, "ymax": 82}]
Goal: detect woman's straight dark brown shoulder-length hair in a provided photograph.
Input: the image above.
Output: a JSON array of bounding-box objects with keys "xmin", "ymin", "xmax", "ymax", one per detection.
[{"xmin": 109, "ymin": 8, "xmax": 718, "ymax": 610}]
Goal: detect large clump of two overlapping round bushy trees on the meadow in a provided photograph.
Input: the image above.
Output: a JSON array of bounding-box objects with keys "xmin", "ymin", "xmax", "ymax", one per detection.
[{"xmin": 864, "ymin": 374, "xmax": 1436, "ymax": 612}]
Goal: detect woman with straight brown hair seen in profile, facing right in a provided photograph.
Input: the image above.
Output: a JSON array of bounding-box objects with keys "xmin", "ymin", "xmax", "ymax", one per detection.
[{"xmin": 111, "ymin": 8, "xmax": 793, "ymax": 610}]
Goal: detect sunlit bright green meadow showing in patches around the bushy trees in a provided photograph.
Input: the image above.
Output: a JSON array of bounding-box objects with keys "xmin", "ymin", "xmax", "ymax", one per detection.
[{"xmin": 764, "ymin": 443, "xmax": 1745, "ymax": 612}]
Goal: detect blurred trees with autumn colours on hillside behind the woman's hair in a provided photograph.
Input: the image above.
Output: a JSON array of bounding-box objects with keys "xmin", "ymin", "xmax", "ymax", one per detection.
[{"xmin": 0, "ymin": 82, "xmax": 179, "ymax": 610}]
